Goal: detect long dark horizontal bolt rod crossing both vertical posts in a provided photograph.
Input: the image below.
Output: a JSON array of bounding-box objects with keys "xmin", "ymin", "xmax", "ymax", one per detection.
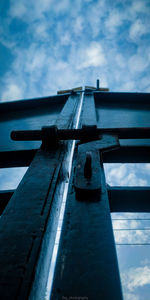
[{"xmin": 11, "ymin": 127, "xmax": 150, "ymax": 141}]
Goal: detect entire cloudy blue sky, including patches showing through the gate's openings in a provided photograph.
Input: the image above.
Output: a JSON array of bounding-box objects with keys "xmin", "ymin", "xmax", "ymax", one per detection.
[{"xmin": 0, "ymin": 0, "xmax": 150, "ymax": 300}]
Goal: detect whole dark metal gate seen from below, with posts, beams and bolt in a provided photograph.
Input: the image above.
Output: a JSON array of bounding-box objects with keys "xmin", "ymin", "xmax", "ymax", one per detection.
[{"xmin": 0, "ymin": 80, "xmax": 150, "ymax": 300}]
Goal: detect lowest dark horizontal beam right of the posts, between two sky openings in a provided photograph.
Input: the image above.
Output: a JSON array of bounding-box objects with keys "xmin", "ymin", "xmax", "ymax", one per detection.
[{"xmin": 107, "ymin": 186, "xmax": 150, "ymax": 212}]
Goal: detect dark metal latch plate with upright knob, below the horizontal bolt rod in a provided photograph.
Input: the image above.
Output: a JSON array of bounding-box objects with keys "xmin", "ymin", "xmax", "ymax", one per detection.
[{"xmin": 74, "ymin": 135, "xmax": 120, "ymax": 201}]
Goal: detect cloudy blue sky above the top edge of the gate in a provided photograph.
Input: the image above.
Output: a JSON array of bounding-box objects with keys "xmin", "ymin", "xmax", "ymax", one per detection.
[{"xmin": 0, "ymin": 0, "xmax": 150, "ymax": 101}]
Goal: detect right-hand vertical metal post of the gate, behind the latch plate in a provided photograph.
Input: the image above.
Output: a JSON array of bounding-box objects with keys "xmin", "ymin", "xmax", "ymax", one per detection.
[{"xmin": 51, "ymin": 95, "xmax": 122, "ymax": 300}]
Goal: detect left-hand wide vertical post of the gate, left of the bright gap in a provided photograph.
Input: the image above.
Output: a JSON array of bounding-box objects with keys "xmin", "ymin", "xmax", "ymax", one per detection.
[{"xmin": 0, "ymin": 97, "xmax": 78, "ymax": 300}]
